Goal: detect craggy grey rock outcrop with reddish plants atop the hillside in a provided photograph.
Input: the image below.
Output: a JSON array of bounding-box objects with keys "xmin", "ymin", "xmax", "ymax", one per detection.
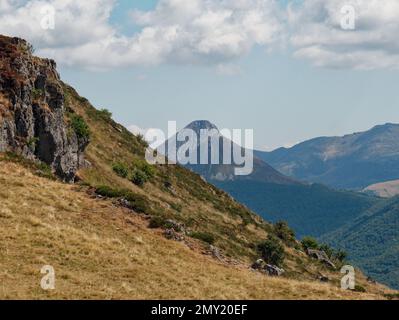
[{"xmin": 0, "ymin": 36, "xmax": 88, "ymax": 181}]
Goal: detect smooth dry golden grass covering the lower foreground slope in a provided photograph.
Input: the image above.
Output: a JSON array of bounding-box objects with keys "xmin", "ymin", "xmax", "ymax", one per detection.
[{"xmin": 0, "ymin": 161, "xmax": 394, "ymax": 299}]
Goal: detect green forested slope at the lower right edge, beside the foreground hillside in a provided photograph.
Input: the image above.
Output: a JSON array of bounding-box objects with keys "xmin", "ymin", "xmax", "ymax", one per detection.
[{"xmin": 323, "ymin": 197, "xmax": 399, "ymax": 288}]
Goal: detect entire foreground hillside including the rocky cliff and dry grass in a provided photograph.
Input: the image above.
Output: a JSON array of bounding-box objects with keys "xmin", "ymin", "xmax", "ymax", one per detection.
[{"xmin": 0, "ymin": 37, "xmax": 394, "ymax": 299}]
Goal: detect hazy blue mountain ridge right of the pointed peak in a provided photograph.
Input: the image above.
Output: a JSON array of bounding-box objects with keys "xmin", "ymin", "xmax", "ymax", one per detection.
[{"xmin": 255, "ymin": 123, "xmax": 399, "ymax": 189}]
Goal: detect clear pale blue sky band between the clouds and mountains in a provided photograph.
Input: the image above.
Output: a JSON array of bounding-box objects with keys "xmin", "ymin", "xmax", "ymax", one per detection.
[{"xmin": 61, "ymin": 45, "xmax": 399, "ymax": 149}]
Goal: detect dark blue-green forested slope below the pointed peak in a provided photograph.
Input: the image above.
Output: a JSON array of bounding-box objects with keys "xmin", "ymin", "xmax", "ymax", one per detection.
[{"xmin": 217, "ymin": 181, "xmax": 379, "ymax": 237}]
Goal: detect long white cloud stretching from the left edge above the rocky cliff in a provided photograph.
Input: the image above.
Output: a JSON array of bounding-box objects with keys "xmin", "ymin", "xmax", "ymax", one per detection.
[{"xmin": 0, "ymin": 0, "xmax": 281, "ymax": 68}]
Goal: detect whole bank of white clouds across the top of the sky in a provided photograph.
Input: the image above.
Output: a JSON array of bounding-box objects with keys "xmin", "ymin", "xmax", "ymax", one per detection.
[{"xmin": 0, "ymin": 0, "xmax": 399, "ymax": 70}]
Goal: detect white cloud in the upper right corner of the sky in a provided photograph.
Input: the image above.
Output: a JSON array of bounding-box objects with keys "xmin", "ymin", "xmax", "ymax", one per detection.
[{"xmin": 288, "ymin": 0, "xmax": 399, "ymax": 69}]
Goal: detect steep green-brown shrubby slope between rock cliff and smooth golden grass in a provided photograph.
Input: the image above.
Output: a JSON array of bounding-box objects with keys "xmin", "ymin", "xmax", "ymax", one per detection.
[{"xmin": 65, "ymin": 86, "xmax": 276, "ymax": 258}]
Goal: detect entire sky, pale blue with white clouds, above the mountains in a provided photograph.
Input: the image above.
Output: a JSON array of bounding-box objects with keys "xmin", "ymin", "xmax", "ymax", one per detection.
[{"xmin": 0, "ymin": 0, "xmax": 399, "ymax": 150}]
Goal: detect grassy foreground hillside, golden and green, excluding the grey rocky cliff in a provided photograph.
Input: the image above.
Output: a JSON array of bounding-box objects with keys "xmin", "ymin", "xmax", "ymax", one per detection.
[{"xmin": 0, "ymin": 85, "xmax": 389, "ymax": 299}]
